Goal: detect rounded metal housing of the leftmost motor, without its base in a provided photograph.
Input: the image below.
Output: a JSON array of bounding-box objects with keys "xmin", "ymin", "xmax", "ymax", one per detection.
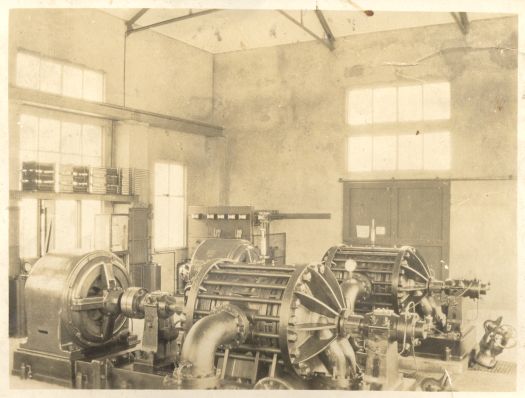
[{"xmin": 25, "ymin": 251, "xmax": 130, "ymax": 351}]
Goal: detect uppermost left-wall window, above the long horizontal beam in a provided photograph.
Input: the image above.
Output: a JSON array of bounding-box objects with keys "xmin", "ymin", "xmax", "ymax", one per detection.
[{"xmin": 16, "ymin": 51, "xmax": 105, "ymax": 102}]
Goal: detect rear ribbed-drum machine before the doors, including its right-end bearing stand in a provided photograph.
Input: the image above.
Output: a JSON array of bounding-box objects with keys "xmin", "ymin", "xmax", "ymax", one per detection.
[{"xmin": 323, "ymin": 245, "xmax": 490, "ymax": 362}]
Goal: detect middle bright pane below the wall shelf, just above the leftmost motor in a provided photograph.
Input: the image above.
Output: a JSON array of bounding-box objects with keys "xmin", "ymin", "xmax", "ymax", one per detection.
[{"xmin": 54, "ymin": 200, "xmax": 77, "ymax": 251}]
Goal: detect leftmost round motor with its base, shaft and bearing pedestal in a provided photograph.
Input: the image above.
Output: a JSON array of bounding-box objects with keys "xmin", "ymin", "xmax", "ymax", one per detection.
[{"xmin": 13, "ymin": 251, "xmax": 182, "ymax": 386}]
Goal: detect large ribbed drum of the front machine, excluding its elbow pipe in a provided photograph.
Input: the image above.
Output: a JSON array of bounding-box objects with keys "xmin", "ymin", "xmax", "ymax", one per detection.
[{"xmin": 185, "ymin": 259, "xmax": 346, "ymax": 377}]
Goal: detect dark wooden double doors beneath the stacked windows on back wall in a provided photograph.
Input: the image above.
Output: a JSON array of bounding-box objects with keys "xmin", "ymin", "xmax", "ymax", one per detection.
[{"xmin": 343, "ymin": 180, "xmax": 450, "ymax": 279}]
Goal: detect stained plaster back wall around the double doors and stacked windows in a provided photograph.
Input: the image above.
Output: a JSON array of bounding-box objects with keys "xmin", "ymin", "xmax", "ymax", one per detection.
[{"xmin": 214, "ymin": 17, "xmax": 517, "ymax": 314}]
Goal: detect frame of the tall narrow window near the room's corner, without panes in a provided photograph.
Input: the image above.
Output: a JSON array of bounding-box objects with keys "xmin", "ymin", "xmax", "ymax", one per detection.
[{"xmin": 153, "ymin": 160, "xmax": 188, "ymax": 253}]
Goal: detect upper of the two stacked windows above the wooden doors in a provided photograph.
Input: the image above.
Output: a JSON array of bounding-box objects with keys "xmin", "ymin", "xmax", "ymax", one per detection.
[{"xmin": 347, "ymin": 82, "xmax": 450, "ymax": 125}]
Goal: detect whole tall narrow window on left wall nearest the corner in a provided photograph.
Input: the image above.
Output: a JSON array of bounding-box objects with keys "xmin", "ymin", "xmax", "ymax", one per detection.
[{"xmin": 154, "ymin": 162, "xmax": 186, "ymax": 251}]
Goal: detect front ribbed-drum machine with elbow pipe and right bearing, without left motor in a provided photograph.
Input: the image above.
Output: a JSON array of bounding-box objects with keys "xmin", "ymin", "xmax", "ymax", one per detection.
[{"xmin": 178, "ymin": 259, "xmax": 427, "ymax": 389}]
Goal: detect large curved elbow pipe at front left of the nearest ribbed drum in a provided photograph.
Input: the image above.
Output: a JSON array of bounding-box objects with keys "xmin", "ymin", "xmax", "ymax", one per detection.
[{"xmin": 181, "ymin": 305, "xmax": 249, "ymax": 378}]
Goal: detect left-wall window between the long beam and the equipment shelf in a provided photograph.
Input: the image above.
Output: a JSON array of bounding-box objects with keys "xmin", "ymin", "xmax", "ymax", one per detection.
[{"xmin": 19, "ymin": 114, "xmax": 103, "ymax": 167}]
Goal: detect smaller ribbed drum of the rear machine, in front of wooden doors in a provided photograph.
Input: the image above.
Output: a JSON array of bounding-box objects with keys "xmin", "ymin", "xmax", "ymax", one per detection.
[{"xmin": 322, "ymin": 245, "xmax": 432, "ymax": 314}]
